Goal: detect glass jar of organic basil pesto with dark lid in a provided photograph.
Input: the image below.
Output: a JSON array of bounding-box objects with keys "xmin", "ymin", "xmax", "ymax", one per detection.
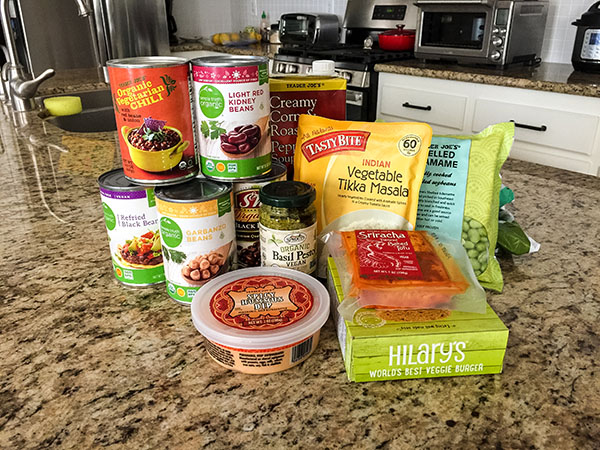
[{"xmin": 259, "ymin": 181, "xmax": 317, "ymax": 274}]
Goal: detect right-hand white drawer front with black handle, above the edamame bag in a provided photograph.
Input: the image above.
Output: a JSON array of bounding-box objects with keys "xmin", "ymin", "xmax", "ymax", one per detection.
[{"xmin": 472, "ymin": 98, "xmax": 599, "ymax": 156}]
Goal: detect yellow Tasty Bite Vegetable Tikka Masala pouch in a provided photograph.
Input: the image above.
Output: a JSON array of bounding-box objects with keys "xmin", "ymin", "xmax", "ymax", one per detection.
[{"xmin": 294, "ymin": 115, "xmax": 432, "ymax": 234}]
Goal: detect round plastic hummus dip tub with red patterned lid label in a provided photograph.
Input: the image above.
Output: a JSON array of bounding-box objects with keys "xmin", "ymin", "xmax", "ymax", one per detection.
[{"xmin": 192, "ymin": 267, "xmax": 329, "ymax": 374}]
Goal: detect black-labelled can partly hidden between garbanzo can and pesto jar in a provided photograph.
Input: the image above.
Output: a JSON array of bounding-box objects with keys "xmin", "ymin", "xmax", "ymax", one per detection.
[{"xmin": 233, "ymin": 161, "xmax": 287, "ymax": 267}]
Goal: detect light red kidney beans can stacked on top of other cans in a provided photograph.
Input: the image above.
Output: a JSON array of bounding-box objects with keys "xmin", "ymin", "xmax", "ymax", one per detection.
[{"xmin": 191, "ymin": 56, "xmax": 271, "ymax": 181}]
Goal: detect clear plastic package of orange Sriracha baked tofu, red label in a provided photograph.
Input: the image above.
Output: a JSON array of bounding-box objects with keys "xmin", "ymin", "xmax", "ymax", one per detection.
[{"xmin": 326, "ymin": 230, "xmax": 486, "ymax": 321}]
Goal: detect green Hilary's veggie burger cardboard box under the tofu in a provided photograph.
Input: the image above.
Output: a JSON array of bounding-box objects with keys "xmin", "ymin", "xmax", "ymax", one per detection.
[{"xmin": 328, "ymin": 258, "xmax": 508, "ymax": 381}]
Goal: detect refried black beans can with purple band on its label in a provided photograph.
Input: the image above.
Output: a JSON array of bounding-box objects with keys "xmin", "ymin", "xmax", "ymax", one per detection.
[{"xmin": 98, "ymin": 169, "xmax": 165, "ymax": 286}]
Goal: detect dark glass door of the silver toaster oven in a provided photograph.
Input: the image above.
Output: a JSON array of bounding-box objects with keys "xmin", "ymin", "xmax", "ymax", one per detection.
[{"xmin": 415, "ymin": 2, "xmax": 494, "ymax": 60}]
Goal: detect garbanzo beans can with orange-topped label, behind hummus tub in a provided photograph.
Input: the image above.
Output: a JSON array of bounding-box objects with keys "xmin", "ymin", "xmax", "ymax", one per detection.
[{"xmin": 155, "ymin": 178, "xmax": 235, "ymax": 305}]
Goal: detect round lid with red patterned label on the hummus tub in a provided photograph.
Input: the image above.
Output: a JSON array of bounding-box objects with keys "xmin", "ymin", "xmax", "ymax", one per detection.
[{"xmin": 191, "ymin": 267, "xmax": 329, "ymax": 350}]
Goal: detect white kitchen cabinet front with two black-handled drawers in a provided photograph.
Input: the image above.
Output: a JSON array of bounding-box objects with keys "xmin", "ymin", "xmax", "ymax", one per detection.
[{"xmin": 377, "ymin": 73, "xmax": 600, "ymax": 176}]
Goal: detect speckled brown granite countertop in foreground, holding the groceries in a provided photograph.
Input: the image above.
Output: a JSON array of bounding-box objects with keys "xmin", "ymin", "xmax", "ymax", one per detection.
[{"xmin": 0, "ymin": 81, "xmax": 600, "ymax": 449}]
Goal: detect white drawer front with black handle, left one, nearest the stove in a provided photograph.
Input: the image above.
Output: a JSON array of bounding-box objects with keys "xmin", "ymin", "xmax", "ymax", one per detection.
[{"xmin": 379, "ymin": 84, "xmax": 468, "ymax": 132}]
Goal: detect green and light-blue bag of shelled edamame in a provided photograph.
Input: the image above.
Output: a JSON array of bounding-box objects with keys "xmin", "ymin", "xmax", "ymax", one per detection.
[{"xmin": 416, "ymin": 123, "xmax": 515, "ymax": 291}]
